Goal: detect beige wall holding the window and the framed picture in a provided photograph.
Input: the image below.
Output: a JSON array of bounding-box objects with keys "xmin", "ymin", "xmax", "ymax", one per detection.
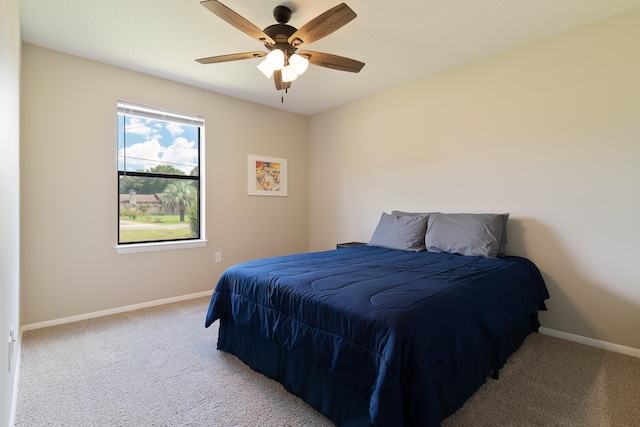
[{"xmin": 21, "ymin": 45, "xmax": 308, "ymax": 324}]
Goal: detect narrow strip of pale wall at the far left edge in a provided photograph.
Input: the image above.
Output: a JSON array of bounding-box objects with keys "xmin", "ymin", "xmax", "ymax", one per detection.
[{"xmin": 0, "ymin": 0, "xmax": 20, "ymax": 426}]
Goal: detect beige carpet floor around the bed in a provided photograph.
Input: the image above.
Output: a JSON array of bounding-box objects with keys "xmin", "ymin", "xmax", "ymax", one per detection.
[{"xmin": 16, "ymin": 298, "xmax": 640, "ymax": 427}]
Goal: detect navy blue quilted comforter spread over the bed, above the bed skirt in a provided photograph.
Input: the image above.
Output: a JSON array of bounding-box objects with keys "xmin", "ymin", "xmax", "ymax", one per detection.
[{"xmin": 206, "ymin": 246, "xmax": 549, "ymax": 426}]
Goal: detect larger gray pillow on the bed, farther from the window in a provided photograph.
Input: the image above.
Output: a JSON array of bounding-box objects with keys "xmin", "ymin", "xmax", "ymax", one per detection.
[{"xmin": 425, "ymin": 213, "xmax": 508, "ymax": 258}]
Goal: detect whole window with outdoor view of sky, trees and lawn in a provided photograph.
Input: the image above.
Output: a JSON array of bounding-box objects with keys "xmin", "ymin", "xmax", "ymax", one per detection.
[{"xmin": 116, "ymin": 102, "xmax": 204, "ymax": 253}]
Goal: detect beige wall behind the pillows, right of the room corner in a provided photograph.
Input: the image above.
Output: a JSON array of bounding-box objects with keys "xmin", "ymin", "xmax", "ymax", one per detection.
[{"xmin": 309, "ymin": 8, "xmax": 640, "ymax": 349}]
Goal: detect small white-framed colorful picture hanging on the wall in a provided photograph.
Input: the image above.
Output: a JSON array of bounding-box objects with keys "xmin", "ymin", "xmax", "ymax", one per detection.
[{"xmin": 247, "ymin": 154, "xmax": 287, "ymax": 196}]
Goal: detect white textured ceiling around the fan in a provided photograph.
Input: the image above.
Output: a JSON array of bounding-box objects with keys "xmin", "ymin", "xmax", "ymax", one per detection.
[{"xmin": 20, "ymin": 0, "xmax": 640, "ymax": 115}]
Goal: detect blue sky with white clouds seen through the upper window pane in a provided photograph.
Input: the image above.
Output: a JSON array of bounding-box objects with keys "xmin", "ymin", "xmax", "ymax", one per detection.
[{"xmin": 118, "ymin": 114, "xmax": 198, "ymax": 175}]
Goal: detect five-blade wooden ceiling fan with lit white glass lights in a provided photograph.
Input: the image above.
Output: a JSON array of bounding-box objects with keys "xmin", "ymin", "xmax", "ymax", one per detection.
[{"xmin": 196, "ymin": 0, "xmax": 364, "ymax": 90}]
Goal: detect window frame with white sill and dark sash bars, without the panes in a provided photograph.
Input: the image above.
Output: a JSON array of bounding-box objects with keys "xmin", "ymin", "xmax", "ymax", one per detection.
[{"xmin": 114, "ymin": 101, "xmax": 207, "ymax": 254}]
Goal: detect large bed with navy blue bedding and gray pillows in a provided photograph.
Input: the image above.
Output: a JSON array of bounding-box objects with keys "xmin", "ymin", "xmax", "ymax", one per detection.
[{"xmin": 205, "ymin": 214, "xmax": 549, "ymax": 426}]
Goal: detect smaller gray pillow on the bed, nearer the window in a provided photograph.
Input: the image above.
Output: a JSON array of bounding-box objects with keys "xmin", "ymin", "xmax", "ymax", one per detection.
[{"xmin": 369, "ymin": 212, "xmax": 428, "ymax": 252}]
